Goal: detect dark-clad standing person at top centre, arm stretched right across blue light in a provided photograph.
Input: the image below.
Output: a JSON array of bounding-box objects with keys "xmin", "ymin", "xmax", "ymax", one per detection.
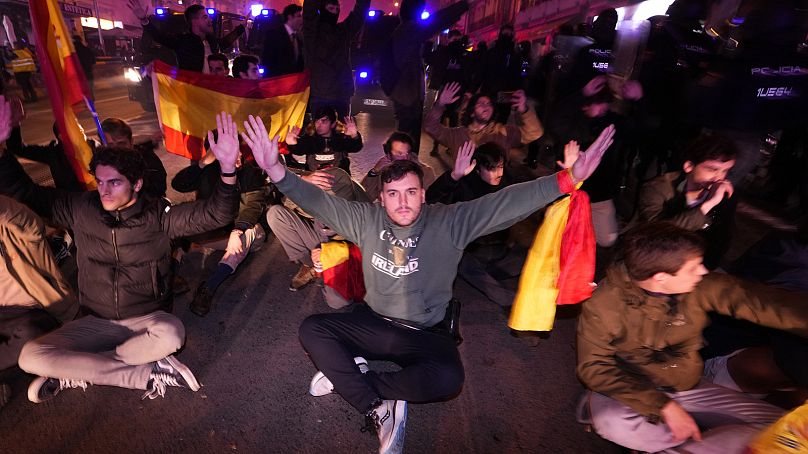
[{"xmin": 381, "ymin": 0, "xmax": 469, "ymax": 152}]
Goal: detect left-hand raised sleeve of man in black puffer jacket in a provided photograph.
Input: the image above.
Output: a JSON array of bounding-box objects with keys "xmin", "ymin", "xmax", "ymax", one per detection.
[{"xmin": 0, "ymin": 151, "xmax": 77, "ymax": 227}]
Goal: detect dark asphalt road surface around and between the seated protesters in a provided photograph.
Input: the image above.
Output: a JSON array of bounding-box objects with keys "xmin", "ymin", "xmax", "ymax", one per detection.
[{"xmin": 0, "ymin": 72, "xmax": 796, "ymax": 454}]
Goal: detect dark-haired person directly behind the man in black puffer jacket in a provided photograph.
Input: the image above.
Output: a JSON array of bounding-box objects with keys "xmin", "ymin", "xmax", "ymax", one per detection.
[{"xmin": 101, "ymin": 117, "xmax": 168, "ymax": 198}]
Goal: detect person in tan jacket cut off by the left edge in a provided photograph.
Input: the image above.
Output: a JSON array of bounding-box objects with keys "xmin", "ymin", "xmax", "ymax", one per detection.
[{"xmin": 0, "ymin": 196, "xmax": 79, "ymax": 407}]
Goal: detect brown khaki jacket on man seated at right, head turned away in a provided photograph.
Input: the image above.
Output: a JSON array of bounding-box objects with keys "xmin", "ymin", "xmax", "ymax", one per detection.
[{"xmin": 578, "ymin": 265, "xmax": 808, "ymax": 419}]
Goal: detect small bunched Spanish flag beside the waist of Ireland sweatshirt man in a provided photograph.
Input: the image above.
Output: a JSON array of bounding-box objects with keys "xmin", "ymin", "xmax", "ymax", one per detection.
[{"xmin": 320, "ymin": 241, "xmax": 365, "ymax": 302}]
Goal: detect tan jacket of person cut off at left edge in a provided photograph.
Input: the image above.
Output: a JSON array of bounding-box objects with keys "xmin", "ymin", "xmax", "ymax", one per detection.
[{"xmin": 0, "ymin": 196, "xmax": 79, "ymax": 322}]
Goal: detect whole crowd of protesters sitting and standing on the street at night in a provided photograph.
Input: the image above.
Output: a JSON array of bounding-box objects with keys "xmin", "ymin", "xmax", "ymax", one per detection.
[{"xmin": 0, "ymin": 0, "xmax": 808, "ymax": 453}]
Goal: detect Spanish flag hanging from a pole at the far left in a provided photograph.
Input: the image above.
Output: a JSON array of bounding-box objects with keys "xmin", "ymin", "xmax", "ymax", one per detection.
[{"xmin": 28, "ymin": 0, "xmax": 95, "ymax": 189}]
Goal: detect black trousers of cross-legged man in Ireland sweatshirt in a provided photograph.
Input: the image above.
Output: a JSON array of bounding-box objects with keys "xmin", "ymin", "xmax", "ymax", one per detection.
[{"xmin": 300, "ymin": 304, "xmax": 464, "ymax": 413}]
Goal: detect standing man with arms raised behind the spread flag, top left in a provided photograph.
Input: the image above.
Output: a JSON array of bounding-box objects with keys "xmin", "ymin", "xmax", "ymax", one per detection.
[{"xmin": 129, "ymin": 0, "xmax": 245, "ymax": 73}]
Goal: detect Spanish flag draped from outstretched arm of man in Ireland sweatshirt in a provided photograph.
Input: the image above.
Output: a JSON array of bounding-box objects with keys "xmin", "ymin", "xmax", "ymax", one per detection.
[{"xmin": 508, "ymin": 189, "xmax": 595, "ymax": 331}]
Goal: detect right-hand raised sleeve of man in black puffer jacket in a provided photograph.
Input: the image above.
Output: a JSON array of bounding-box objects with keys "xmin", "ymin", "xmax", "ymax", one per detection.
[{"xmin": 161, "ymin": 178, "xmax": 239, "ymax": 238}]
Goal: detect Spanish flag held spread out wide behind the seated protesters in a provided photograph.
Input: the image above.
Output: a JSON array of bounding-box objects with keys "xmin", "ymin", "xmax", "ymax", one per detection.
[{"xmin": 152, "ymin": 60, "xmax": 309, "ymax": 160}]
